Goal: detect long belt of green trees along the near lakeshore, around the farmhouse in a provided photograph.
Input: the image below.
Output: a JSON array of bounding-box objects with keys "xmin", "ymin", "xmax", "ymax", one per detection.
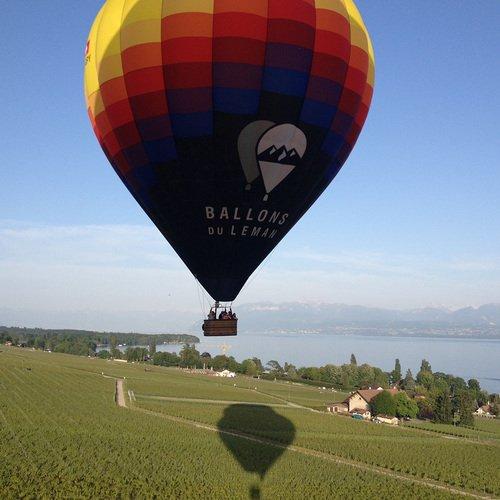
[{"xmin": 156, "ymin": 345, "xmax": 499, "ymax": 426}]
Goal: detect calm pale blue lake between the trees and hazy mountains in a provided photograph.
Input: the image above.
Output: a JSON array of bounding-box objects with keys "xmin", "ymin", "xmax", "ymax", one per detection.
[{"xmin": 153, "ymin": 333, "xmax": 500, "ymax": 393}]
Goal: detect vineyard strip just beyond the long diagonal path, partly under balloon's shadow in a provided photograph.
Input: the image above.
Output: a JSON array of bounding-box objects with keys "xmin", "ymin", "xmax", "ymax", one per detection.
[{"xmin": 136, "ymin": 395, "xmax": 500, "ymax": 495}]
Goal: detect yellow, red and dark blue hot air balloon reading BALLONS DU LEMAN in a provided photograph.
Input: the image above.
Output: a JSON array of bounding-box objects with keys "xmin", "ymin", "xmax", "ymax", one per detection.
[{"xmin": 85, "ymin": 0, "xmax": 374, "ymax": 334}]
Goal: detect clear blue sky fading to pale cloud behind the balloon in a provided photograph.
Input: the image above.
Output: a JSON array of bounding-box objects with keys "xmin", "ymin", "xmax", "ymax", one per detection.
[{"xmin": 0, "ymin": 0, "xmax": 500, "ymax": 326}]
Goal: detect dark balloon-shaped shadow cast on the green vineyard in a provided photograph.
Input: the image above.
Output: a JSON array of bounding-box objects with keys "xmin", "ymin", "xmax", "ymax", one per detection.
[{"xmin": 217, "ymin": 404, "xmax": 295, "ymax": 499}]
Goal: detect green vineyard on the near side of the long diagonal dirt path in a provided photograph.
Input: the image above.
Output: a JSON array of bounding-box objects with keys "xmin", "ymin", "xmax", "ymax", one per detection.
[{"xmin": 0, "ymin": 351, "xmax": 460, "ymax": 499}]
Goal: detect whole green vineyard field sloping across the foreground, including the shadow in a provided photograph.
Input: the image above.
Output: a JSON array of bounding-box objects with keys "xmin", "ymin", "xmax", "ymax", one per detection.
[{"xmin": 0, "ymin": 347, "xmax": 500, "ymax": 499}]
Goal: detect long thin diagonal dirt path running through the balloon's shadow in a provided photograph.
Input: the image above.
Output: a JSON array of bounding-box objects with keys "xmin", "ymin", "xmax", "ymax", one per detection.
[{"xmin": 130, "ymin": 406, "xmax": 495, "ymax": 499}]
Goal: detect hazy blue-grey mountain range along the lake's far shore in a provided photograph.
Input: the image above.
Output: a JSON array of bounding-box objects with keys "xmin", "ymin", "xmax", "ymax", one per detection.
[{"xmin": 0, "ymin": 302, "xmax": 500, "ymax": 339}]
